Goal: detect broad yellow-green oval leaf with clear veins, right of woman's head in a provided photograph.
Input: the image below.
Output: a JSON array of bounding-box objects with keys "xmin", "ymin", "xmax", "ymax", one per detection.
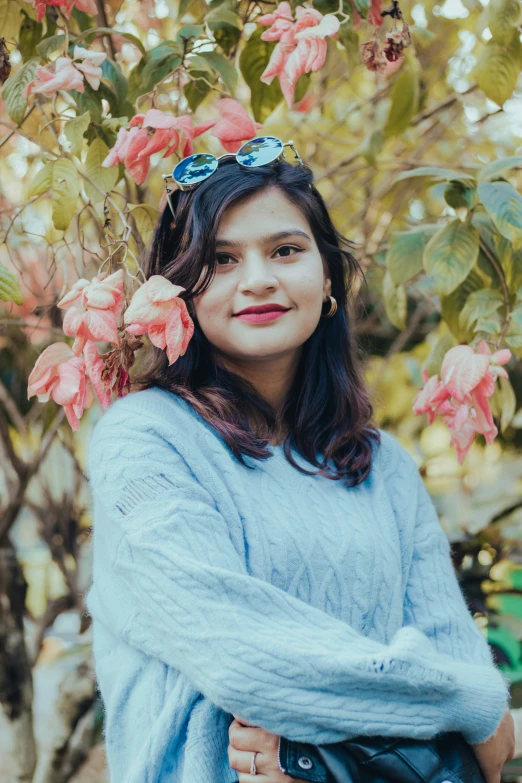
[{"xmin": 423, "ymin": 218, "xmax": 479, "ymax": 296}]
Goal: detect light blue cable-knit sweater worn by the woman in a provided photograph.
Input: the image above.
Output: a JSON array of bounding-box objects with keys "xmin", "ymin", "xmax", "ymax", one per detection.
[{"xmin": 87, "ymin": 388, "xmax": 509, "ymax": 783}]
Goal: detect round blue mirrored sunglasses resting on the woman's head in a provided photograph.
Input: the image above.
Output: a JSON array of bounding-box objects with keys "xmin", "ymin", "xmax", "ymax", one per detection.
[{"xmin": 163, "ymin": 136, "xmax": 303, "ymax": 213}]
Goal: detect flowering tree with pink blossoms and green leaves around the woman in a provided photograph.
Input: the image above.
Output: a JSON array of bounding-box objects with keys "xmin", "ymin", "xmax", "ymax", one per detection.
[{"xmin": 0, "ymin": 0, "xmax": 522, "ymax": 776}]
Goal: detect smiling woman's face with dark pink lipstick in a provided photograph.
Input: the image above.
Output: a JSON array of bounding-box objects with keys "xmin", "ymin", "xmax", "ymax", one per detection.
[{"xmin": 193, "ymin": 188, "xmax": 331, "ymax": 362}]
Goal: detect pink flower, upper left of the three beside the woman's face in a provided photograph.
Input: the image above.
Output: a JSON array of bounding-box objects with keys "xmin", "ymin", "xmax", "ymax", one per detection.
[{"xmin": 58, "ymin": 269, "xmax": 124, "ymax": 356}]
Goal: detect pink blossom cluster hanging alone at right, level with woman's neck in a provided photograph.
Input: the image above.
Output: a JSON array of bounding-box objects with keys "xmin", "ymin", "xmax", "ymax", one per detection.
[{"xmin": 413, "ymin": 340, "xmax": 511, "ymax": 464}]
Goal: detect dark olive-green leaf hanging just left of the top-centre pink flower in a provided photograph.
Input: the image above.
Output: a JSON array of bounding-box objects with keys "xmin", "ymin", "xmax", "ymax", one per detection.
[{"xmin": 239, "ymin": 27, "xmax": 283, "ymax": 122}]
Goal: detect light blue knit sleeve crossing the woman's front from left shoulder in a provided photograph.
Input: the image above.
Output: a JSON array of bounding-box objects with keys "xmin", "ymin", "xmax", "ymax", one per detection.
[{"xmin": 87, "ymin": 404, "xmax": 506, "ymax": 743}]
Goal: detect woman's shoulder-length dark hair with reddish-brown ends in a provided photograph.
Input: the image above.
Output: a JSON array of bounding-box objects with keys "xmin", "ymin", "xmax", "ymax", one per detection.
[{"xmin": 133, "ymin": 158, "xmax": 380, "ymax": 486}]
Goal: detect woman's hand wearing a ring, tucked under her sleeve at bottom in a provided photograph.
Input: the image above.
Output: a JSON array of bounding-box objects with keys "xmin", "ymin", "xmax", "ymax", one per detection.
[{"xmin": 228, "ymin": 715, "xmax": 303, "ymax": 783}]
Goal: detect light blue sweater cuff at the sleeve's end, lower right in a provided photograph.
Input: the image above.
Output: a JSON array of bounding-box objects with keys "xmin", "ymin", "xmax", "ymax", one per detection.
[{"xmin": 438, "ymin": 660, "xmax": 510, "ymax": 745}]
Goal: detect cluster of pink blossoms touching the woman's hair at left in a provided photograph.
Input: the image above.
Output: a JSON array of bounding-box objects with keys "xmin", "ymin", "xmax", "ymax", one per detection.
[{"xmin": 27, "ymin": 269, "xmax": 194, "ymax": 430}]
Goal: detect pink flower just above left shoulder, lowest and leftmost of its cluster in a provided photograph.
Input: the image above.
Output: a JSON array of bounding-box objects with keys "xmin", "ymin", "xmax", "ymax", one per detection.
[{"xmin": 27, "ymin": 343, "xmax": 94, "ymax": 430}]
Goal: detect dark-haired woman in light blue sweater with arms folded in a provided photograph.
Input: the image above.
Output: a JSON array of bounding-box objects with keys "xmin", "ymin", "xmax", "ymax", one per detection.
[{"xmin": 87, "ymin": 149, "xmax": 513, "ymax": 783}]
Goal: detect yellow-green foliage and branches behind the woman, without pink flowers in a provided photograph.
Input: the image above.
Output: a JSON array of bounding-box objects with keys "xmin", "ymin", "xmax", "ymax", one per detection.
[{"xmin": 0, "ymin": 0, "xmax": 522, "ymax": 783}]
